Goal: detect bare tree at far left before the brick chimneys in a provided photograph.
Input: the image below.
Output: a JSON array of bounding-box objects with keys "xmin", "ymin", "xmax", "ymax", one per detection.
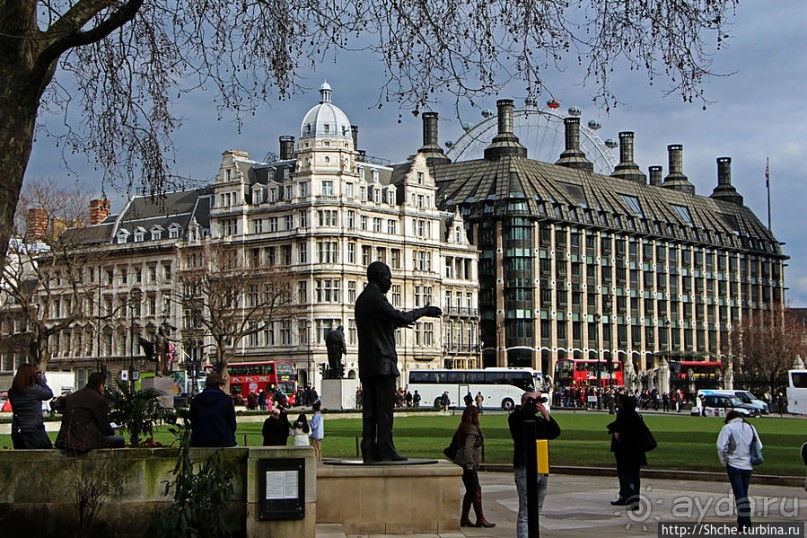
[{"xmin": 0, "ymin": 182, "xmax": 103, "ymax": 371}]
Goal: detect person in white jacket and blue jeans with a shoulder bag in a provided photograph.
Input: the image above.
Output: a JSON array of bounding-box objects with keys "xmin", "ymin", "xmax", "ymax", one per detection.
[{"xmin": 717, "ymin": 411, "xmax": 762, "ymax": 532}]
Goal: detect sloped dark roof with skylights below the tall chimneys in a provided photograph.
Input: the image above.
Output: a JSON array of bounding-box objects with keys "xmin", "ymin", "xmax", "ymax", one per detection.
[{"xmin": 402, "ymin": 156, "xmax": 782, "ymax": 256}]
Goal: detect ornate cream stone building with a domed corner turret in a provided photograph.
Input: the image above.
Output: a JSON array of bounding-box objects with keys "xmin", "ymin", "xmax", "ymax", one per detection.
[{"xmin": 4, "ymin": 83, "xmax": 481, "ymax": 386}]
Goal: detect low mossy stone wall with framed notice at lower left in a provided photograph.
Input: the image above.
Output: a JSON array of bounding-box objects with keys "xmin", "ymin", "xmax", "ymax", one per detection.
[{"xmin": 0, "ymin": 447, "xmax": 316, "ymax": 538}]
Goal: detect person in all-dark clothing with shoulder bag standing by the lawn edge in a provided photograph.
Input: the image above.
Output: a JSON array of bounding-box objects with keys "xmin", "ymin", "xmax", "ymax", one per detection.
[{"xmin": 607, "ymin": 394, "xmax": 647, "ymax": 510}]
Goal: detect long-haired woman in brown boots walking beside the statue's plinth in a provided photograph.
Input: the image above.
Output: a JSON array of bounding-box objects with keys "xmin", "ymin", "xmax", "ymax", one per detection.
[{"xmin": 454, "ymin": 405, "xmax": 496, "ymax": 527}]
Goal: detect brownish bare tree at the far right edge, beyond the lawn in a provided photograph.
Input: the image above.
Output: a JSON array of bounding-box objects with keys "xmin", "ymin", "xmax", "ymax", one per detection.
[{"xmin": 732, "ymin": 305, "xmax": 807, "ymax": 391}]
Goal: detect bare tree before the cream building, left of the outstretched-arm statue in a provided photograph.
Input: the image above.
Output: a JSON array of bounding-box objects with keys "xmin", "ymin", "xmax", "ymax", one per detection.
[{"xmin": 177, "ymin": 243, "xmax": 297, "ymax": 388}]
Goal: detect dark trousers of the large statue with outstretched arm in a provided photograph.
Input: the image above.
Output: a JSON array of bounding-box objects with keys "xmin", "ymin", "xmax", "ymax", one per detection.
[{"xmin": 361, "ymin": 375, "xmax": 396, "ymax": 461}]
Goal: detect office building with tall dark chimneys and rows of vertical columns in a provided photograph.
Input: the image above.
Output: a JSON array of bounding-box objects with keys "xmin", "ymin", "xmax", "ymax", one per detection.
[{"xmin": 408, "ymin": 100, "xmax": 787, "ymax": 381}]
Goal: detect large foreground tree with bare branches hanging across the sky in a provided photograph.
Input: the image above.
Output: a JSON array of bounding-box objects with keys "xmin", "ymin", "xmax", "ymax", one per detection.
[{"xmin": 0, "ymin": 0, "xmax": 739, "ymax": 262}]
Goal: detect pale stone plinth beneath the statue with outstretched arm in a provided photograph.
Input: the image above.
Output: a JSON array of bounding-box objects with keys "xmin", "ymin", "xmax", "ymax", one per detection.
[{"xmin": 317, "ymin": 461, "xmax": 462, "ymax": 535}]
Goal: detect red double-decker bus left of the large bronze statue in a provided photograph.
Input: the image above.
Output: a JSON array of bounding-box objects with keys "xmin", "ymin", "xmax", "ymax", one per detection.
[{"xmin": 227, "ymin": 361, "xmax": 297, "ymax": 405}]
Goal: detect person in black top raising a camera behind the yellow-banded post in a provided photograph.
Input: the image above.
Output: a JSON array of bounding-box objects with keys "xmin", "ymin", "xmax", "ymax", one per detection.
[{"xmin": 507, "ymin": 392, "xmax": 560, "ymax": 538}]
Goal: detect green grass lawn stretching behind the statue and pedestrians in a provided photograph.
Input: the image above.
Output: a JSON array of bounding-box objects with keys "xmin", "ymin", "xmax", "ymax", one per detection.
[{"xmin": 0, "ymin": 412, "xmax": 807, "ymax": 476}]
